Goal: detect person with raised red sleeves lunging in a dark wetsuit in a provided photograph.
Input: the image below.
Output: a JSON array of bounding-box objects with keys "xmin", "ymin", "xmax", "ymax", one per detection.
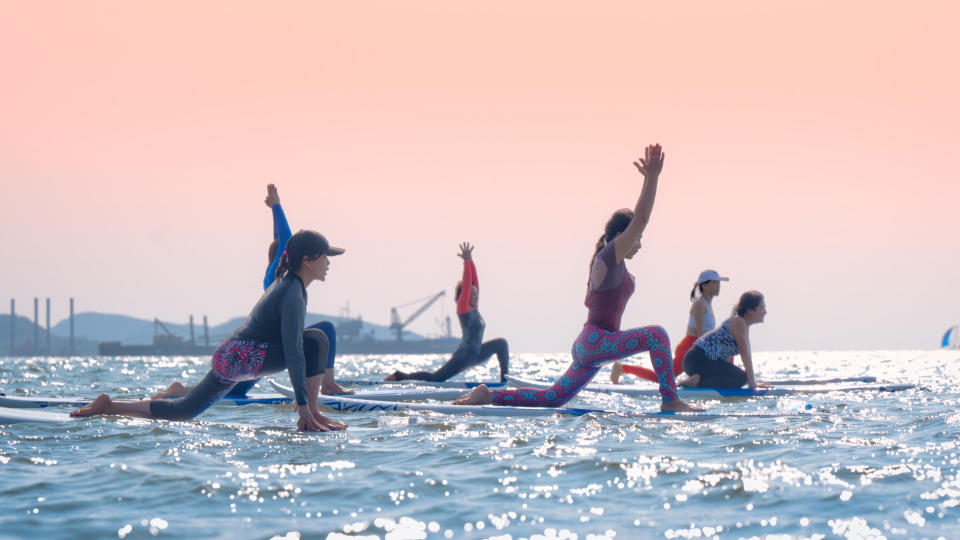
[{"xmin": 386, "ymin": 242, "xmax": 510, "ymax": 382}]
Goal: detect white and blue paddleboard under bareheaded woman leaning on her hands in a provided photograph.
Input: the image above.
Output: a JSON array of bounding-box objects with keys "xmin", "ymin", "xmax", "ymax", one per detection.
[{"xmin": 507, "ymin": 375, "xmax": 916, "ymax": 399}]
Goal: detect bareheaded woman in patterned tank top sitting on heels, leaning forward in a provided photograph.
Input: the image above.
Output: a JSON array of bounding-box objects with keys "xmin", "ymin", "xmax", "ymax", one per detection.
[{"xmin": 683, "ymin": 291, "xmax": 770, "ymax": 388}]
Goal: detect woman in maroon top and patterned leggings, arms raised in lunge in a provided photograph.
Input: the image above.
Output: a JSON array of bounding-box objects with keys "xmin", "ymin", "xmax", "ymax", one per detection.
[{"xmin": 454, "ymin": 144, "xmax": 703, "ymax": 411}]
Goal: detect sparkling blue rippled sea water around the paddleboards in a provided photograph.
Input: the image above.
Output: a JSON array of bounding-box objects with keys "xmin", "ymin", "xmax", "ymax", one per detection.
[{"xmin": 0, "ymin": 351, "xmax": 960, "ymax": 540}]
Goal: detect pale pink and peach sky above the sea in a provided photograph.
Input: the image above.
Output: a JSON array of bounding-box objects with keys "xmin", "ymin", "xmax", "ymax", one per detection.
[{"xmin": 0, "ymin": 0, "xmax": 960, "ymax": 352}]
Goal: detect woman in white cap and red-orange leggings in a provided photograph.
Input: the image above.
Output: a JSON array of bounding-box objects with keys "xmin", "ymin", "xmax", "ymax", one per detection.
[{"xmin": 610, "ymin": 270, "xmax": 733, "ymax": 386}]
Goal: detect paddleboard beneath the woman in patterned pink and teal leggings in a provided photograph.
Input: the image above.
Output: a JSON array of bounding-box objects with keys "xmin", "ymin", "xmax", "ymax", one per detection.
[{"xmin": 319, "ymin": 396, "xmax": 810, "ymax": 421}]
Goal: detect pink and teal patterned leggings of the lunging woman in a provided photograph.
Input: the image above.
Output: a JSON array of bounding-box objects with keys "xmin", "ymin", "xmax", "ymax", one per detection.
[{"xmin": 493, "ymin": 325, "xmax": 677, "ymax": 407}]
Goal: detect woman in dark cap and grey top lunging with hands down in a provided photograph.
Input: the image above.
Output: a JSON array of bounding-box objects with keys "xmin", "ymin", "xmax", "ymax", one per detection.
[{"xmin": 70, "ymin": 231, "xmax": 347, "ymax": 431}]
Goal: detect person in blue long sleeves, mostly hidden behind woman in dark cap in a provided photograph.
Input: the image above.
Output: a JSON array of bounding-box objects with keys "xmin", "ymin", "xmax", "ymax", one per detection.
[{"xmin": 153, "ymin": 184, "xmax": 353, "ymax": 399}]
